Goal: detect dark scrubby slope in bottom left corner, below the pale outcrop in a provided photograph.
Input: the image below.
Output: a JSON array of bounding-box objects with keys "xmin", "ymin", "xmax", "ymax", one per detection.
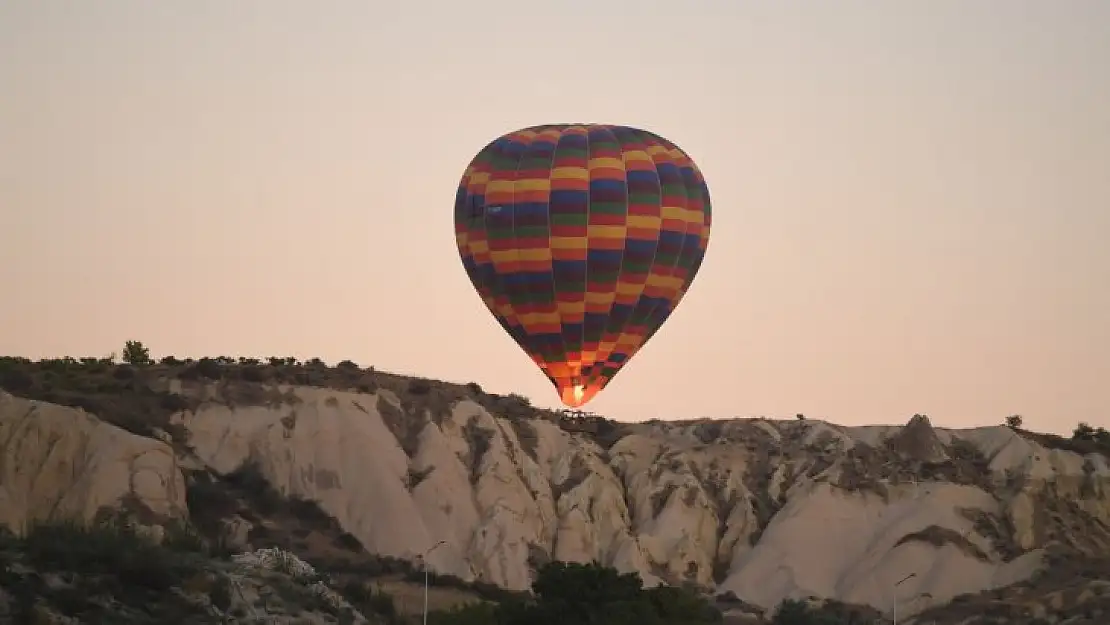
[{"xmin": 0, "ymin": 518, "xmax": 337, "ymax": 625}]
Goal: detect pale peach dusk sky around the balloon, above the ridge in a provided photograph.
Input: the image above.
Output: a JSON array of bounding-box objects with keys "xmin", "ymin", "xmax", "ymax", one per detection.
[{"xmin": 0, "ymin": 0, "xmax": 1110, "ymax": 432}]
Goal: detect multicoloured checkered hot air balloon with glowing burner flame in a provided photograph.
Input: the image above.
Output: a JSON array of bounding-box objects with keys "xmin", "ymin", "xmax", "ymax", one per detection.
[{"xmin": 455, "ymin": 124, "xmax": 710, "ymax": 407}]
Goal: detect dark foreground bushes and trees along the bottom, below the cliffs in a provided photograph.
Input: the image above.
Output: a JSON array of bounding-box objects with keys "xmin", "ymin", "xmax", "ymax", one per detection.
[{"xmin": 0, "ymin": 517, "xmax": 872, "ymax": 625}]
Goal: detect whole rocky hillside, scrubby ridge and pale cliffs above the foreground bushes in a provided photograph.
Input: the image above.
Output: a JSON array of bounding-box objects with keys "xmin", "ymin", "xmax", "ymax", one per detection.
[{"xmin": 0, "ymin": 359, "xmax": 1110, "ymax": 624}]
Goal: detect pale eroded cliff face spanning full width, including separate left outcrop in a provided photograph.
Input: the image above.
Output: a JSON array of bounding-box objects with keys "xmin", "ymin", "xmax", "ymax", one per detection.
[{"xmin": 0, "ymin": 382, "xmax": 1110, "ymax": 614}]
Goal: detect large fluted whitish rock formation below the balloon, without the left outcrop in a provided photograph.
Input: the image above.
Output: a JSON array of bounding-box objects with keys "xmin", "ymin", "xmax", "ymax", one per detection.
[{"xmin": 170, "ymin": 389, "xmax": 1110, "ymax": 611}]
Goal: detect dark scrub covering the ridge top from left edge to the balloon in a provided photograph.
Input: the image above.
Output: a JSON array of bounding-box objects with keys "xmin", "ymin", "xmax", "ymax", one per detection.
[{"xmin": 0, "ymin": 341, "xmax": 624, "ymax": 448}]
